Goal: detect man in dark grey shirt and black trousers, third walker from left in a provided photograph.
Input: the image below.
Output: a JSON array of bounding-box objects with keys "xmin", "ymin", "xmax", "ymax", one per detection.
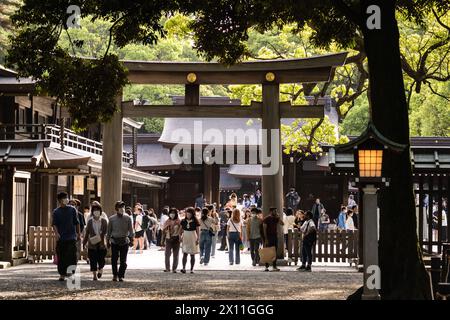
[{"xmin": 106, "ymin": 201, "xmax": 134, "ymax": 282}]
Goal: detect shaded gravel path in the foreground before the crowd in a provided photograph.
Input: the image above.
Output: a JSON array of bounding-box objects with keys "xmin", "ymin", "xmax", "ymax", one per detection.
[{"xmin": 0, "ymin": 263, "xmax": 362, "ymax": 300}]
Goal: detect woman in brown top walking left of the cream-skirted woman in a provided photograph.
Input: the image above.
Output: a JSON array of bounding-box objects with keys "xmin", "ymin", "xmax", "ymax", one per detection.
[{"xmin": 163, "ymin": 208, "xmax": 181, "ymax": 273}]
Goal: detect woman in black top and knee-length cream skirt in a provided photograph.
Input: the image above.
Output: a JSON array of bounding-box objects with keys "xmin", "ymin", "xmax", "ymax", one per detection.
[{"xmin": 181, "ymin": 207, "xmax": 200, "ymax": 273}]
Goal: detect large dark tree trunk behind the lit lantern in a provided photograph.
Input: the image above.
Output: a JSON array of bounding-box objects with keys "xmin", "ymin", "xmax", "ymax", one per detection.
[{"xmin": 361, "ymin": 0, "xmax": 432, "ymax": 299}]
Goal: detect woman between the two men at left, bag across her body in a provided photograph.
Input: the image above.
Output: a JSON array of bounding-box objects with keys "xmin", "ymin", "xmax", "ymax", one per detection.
[{"xmin": 83, "ymin": 202, "xmax": 108, "ymax": 281}]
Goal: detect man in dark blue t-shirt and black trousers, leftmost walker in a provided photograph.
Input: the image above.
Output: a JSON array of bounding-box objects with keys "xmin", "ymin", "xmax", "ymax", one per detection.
[{"xmin": 52, "ymin": 192, "xmax": 81, "ymax": 281}]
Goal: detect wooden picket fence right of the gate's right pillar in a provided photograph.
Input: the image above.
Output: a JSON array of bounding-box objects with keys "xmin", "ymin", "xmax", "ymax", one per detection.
[{"xmin": 287, "ymin": 230, "xmax": 359, "ymax": 266}]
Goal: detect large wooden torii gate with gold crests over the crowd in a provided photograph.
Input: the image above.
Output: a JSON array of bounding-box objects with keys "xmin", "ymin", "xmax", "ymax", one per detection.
[{"xmin": 101, "ymin": 52, "xmax": 347, "ymax": 255}]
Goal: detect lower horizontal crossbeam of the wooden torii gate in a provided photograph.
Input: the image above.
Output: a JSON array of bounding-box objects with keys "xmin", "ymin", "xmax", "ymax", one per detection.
[{"xmin": 122, "ymin": 101, "xmax": 324, "ymax": 119}]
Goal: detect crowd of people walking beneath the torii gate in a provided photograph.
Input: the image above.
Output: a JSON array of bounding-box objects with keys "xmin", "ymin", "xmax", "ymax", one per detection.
[{"xmin": 53, "ymin": 189, "xmax": 357, "ymax": 281}]
